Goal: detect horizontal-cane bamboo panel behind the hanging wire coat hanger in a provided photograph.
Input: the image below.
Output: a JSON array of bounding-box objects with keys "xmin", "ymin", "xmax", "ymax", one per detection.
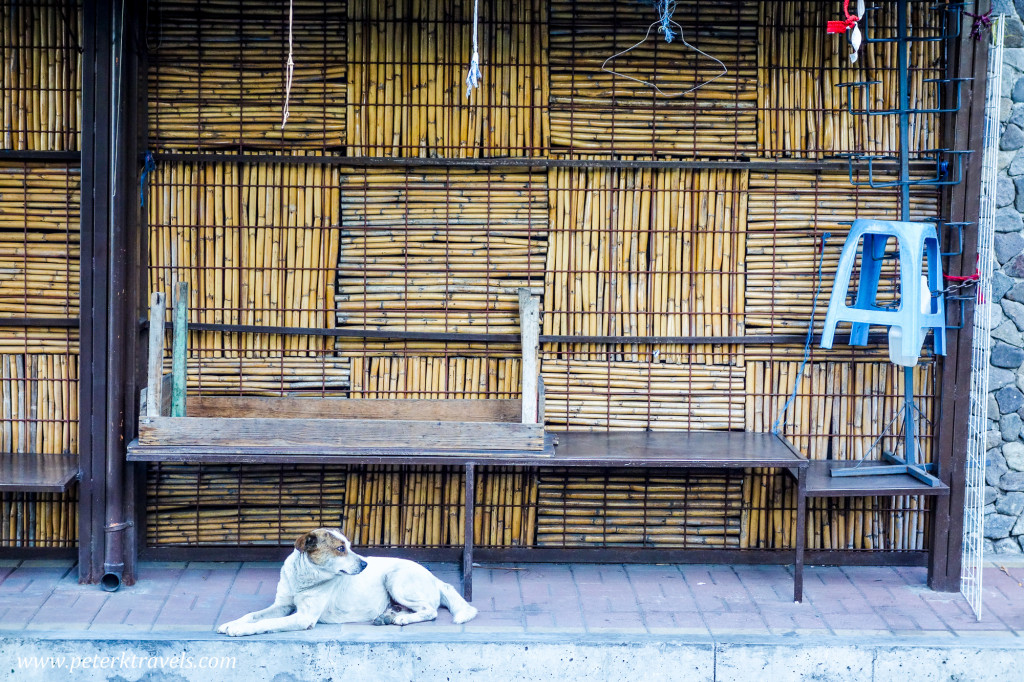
[{"xmin": 550, "ymin": 0, "xmax": 758, "ymax": 158}]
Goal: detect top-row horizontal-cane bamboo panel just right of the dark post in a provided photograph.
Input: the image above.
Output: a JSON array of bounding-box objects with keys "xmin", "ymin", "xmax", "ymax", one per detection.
[{"xmin": 146, "ymin": 0, "xmax": 347, "ymax": 151}]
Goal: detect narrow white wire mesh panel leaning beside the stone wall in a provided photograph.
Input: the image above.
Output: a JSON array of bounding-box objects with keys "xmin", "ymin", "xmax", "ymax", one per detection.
[{"xmin": 961, "ymin": 16, "xmax": 1005, "ymax": 621}]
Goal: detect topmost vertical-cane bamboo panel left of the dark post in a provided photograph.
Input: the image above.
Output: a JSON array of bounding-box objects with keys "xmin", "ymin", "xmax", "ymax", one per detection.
[{"xmin": 0, "ymin": 0, "xmax": 82, "ymax": 152}]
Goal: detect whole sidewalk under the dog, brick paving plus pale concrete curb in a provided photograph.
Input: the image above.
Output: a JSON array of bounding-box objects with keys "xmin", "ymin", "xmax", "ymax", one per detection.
[{"xmin": 0, "ymin": 561, "xmax": 1024, "ymax": 682}]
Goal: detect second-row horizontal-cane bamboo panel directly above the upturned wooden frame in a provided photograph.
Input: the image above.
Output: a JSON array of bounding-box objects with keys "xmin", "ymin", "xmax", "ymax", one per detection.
[{"xmin": 337, "ymin": 169, "xmax": 548, "ymax": 334}]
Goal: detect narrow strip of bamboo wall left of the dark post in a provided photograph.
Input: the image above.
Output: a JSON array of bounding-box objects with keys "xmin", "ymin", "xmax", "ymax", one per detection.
[{"xmin": 0, "ymin": 0, "xmax": 81, "ymax": 548}]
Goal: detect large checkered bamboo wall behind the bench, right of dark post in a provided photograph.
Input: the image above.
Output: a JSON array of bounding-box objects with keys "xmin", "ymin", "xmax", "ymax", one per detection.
[{"xmin": 146, "ymin": 0, "xmax": 944, "ymax": 550}]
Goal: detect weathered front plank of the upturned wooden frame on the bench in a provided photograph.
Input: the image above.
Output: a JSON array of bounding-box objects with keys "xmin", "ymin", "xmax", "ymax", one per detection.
[{"xmin": 138, "ymin": 417, "xmax": 544, "ymax": 451}]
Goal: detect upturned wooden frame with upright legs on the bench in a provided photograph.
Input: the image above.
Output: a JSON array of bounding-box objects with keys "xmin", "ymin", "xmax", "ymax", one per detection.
[{"xmin": 137, "ymin": 282, "xmax": 551, "ymax": 460}]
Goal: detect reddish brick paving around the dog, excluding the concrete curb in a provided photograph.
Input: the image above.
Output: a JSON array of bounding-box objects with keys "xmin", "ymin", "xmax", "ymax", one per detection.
[{"xmin": 0, "ymin": 560, "xmax": 1024, "ymax": 638}]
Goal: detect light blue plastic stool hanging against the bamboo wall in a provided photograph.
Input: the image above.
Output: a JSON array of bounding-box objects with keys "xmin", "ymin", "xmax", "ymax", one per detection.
[{"xmin": 821, "ymin": 219, "xmax": 946, "ymax": 365}]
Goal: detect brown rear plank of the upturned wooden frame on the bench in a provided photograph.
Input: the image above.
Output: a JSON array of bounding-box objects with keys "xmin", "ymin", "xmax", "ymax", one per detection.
[{"xmin": 188, "ymin": 395, "xmax": 522, "ymax": 424}]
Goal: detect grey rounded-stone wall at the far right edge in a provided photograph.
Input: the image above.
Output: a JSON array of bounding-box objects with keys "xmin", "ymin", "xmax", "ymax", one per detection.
[{"xmin": 985, "ymin": 0, "xmax": 1024, "ymax": 554}]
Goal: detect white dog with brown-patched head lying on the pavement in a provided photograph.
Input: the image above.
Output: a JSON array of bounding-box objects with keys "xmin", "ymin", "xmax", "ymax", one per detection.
[{"xmin": 217, "ymin": 528, "xmax": 476, "ymax": 637}]
